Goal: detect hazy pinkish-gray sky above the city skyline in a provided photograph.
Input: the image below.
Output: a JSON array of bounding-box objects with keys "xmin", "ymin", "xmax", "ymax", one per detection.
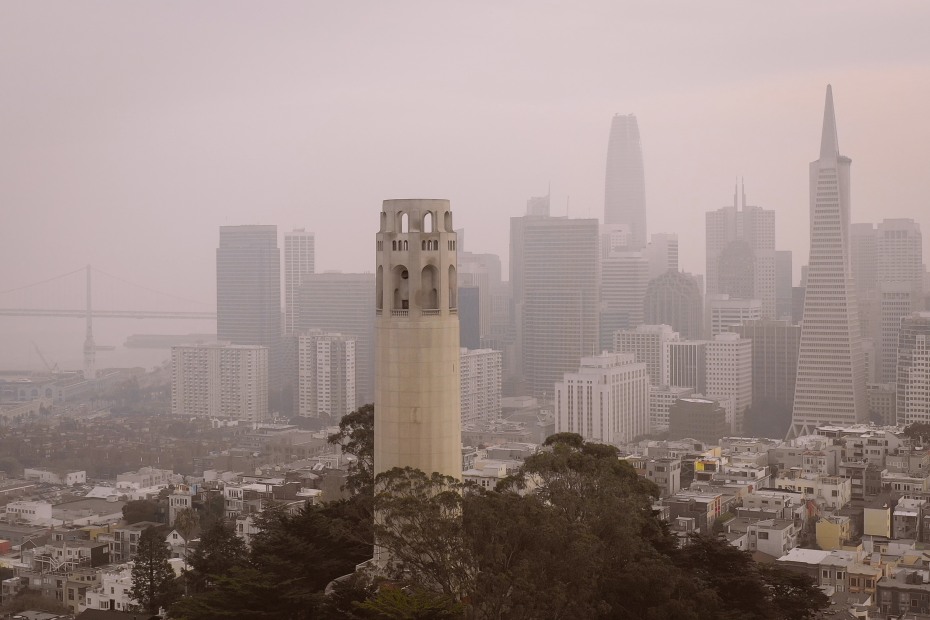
[{"xmin": 0, "ymin": 0, "xmax": 930, "ymax": 308}]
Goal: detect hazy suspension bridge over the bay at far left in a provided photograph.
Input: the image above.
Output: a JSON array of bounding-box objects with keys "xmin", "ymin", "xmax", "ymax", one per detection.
[{"xmin": 0, "ymin": 265, "xmax": 216, "ymax": 379}]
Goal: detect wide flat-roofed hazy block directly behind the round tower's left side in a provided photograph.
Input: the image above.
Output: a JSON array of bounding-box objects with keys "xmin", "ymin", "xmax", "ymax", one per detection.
[{"xmin": 297, "ymin": 272, "xmax": 375, "ymax": 406}]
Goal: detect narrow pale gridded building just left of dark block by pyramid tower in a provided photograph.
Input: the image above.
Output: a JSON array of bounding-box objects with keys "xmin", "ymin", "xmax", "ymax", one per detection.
[{"xmin": 705, "ymin": 332, "xmax": 752, "ymax": 435}]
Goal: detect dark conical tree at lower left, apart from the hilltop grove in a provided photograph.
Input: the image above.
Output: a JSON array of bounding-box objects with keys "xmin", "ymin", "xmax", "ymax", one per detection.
[{"xmin": 130, "ymin": 527, "xmax": 180, "ymax": 613}]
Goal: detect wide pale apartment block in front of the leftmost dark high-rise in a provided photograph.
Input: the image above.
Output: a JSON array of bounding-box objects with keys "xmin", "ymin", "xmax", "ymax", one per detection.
[{"xmin": 171, "ymin": 344, "xmax": 268, "ymax": 422}]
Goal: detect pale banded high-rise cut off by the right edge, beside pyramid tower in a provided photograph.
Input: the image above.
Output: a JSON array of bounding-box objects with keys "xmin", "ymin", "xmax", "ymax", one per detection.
[{"xmin": 896, "ymin": 312, "xmax": 930, "ymax": 425}]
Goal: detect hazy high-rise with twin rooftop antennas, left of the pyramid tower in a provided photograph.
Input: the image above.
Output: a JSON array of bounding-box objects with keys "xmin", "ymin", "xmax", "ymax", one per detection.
[{"xmin": 706, "ymin": 183, "xmax": 777, "ymax": 318}]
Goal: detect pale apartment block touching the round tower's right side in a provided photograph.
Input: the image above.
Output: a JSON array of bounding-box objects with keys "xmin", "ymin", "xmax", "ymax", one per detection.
[{"xmin": 459, "ymin": 349, "xmax": 503, "ymax": 428}]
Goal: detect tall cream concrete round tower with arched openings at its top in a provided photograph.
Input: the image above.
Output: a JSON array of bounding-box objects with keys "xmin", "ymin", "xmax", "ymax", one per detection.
[{"xmin": 375, "ymin": 199, "xmax": 462, "ymax": 478}]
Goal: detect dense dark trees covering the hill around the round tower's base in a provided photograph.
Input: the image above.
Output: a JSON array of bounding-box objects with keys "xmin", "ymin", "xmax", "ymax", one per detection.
[{"xmin": 163, "ymin": 406, "xmax": 826, "ymax": 620}]
